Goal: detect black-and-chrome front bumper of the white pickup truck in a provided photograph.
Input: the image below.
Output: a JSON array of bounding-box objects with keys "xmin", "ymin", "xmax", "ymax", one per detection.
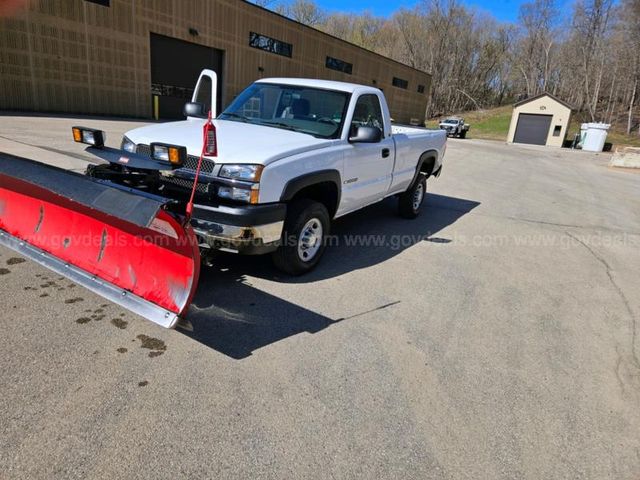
[{"xmin": 191, "ymin": 203, "xmax": 287, "ymax": 255}]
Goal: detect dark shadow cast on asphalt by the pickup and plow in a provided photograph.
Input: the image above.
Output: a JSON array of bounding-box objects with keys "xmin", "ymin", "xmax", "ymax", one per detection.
[{"xmin": 184, "ymin": 194, "xmax": 479, "ymax": 359}]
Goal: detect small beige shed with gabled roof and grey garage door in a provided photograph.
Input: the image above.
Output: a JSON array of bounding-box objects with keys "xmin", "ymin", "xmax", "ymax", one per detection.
[{"xmin": 507, "ymin": 93, "xmax": 572, "ymax": 147}]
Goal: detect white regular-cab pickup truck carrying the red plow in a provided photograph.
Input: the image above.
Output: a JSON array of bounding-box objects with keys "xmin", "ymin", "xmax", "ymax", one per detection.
[{"xmin": 87, "ymin": 70, "xmax": 446, "ymax": 275}]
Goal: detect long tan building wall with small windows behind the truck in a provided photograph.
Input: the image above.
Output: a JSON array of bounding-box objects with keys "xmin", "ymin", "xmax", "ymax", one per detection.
[{"xmin": 0, "ymin": 0, "xmax": 431, "ymax": 122}]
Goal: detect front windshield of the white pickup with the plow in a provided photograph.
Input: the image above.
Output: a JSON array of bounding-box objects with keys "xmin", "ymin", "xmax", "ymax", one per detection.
[{"xmin": 218, "ymin": 83, "xmax": 349, "ymax": 138}]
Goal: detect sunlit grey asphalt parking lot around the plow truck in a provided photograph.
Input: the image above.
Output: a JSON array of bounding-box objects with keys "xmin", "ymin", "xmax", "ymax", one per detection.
[{"xmin": 0, "ymin": 116, "xmax": 640, "ymax": 480}]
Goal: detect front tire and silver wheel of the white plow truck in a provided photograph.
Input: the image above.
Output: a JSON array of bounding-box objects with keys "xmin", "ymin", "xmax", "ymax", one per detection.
[{"xmin": 273, "ymin": 198, "xmax": 331, "ymax": 276}]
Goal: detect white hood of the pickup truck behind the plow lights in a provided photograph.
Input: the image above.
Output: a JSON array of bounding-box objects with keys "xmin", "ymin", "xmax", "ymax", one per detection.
[{"xmin": 125, "ymin": 119, "xmax": 335, "ymax": 165}]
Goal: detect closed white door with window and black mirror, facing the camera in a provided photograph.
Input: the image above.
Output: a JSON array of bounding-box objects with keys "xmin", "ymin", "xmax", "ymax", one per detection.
[{"xmin": 338, "ymin": 94, "xmax": 395, "ymax": 214}]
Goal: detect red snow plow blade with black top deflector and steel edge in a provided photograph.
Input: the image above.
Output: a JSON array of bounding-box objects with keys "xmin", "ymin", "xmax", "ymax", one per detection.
[{"xmin": 0, "ymin": 153, "xmax": 200, "ymax": 328}]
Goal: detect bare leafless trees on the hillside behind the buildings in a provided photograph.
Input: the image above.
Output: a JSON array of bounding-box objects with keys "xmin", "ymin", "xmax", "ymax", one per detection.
[{"xmin": 256, "ymin": 0, "xmax": 640, "ymax": 134}]
